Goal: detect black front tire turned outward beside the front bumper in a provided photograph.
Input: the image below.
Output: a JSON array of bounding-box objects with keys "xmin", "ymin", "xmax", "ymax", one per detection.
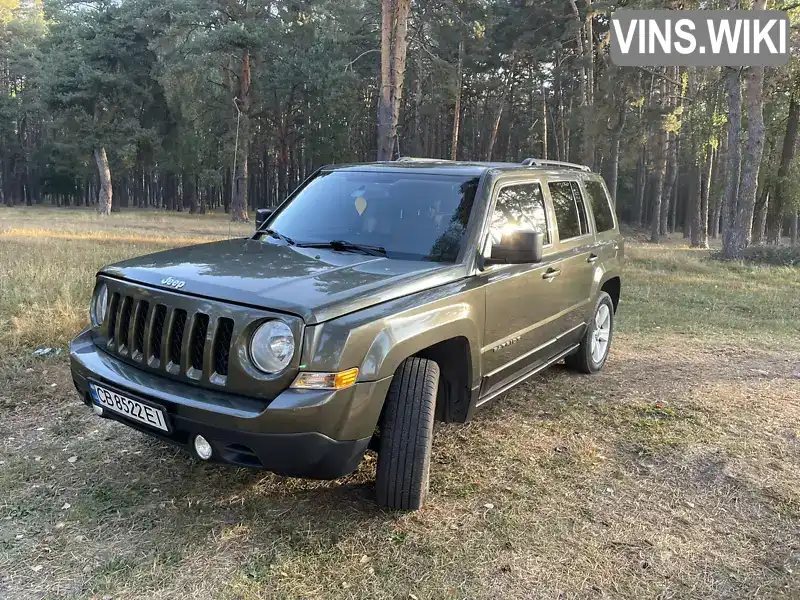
[{"xmin": 375, "ymin": 357, "xmax": 439, "ymax": 510}]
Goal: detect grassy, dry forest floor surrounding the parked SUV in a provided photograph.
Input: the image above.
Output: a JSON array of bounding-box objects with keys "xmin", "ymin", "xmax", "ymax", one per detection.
[{"xmin": 0, "ymin": 208, "xmax": 800, "ymax": 600}]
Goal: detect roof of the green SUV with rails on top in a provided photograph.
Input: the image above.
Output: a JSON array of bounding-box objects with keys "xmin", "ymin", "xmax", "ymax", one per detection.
[{"xmin": 323, "ymin": 157, "xmax": 591, "ymax": 176}]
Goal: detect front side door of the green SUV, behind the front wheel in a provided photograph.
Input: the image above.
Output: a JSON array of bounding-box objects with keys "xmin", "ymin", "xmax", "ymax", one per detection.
[{"xmin": 481, "ymin": 181, "xmax": 563, "ymax": 395}]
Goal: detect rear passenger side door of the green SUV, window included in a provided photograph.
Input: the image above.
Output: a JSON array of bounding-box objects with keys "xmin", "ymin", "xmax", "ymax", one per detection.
[{"xmin": 547, "ymin": 178, "xmax": 599, "ymax": 348}]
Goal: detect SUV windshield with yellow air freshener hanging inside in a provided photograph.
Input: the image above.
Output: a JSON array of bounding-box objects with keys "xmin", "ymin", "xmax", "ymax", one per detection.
[{"xmin": 266, "ymin": 171, "xmax": 478, "ymax": 262}]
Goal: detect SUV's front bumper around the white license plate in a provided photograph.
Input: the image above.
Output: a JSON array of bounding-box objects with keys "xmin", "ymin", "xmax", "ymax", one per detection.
[{"xmin": 70, "ymin": 330, "xmax": 391, "ymax": 479}]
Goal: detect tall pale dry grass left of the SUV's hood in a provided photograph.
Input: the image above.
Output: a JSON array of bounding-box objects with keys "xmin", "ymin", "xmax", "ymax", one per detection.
[{"xmin": 0, "ymin": 208, "xmax": 252, "ymax": 350}]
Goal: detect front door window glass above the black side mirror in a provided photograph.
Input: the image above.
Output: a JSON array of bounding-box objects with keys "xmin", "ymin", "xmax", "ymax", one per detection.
[{"xmin": 489, "ymin": 183, "xmax": 550, "ymax": 245}]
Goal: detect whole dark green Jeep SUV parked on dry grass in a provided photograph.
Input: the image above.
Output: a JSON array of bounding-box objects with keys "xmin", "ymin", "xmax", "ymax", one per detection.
[{"xmin": 70, "ymin": 159, "xmax": 623, "ymax": 509}]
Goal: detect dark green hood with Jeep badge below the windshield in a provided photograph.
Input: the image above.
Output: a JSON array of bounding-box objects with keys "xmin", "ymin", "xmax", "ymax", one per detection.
[{"xmin": 101, "ymin": 238, "xmax": 465, "ymax": 324}]
